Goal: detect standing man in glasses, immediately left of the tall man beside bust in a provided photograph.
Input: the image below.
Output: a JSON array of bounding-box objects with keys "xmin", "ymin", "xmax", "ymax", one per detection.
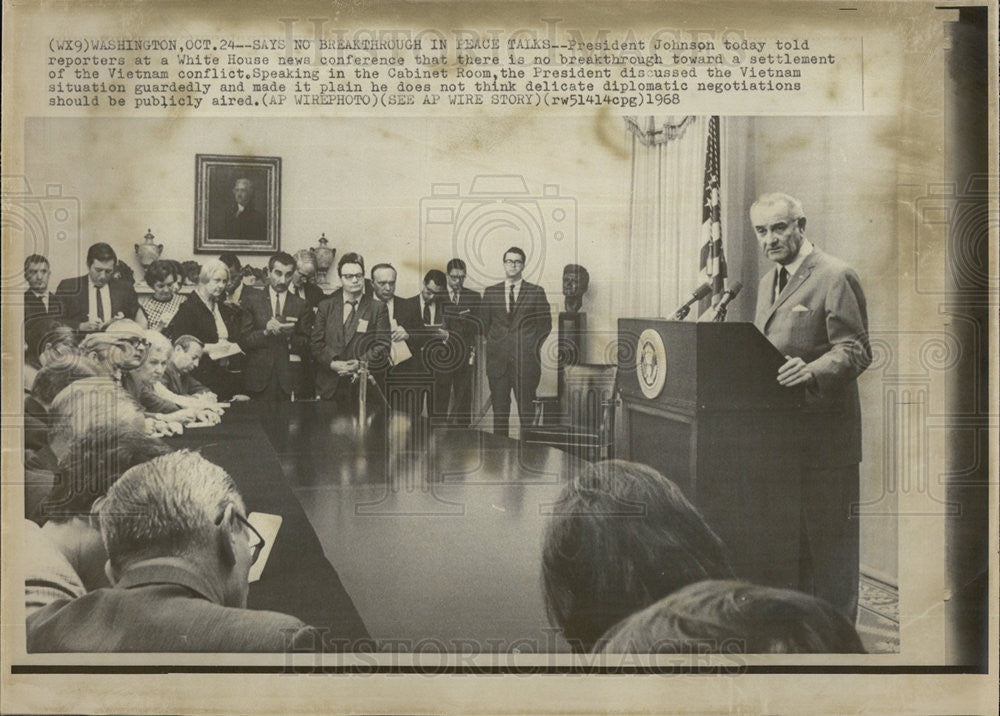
[{"xmin": 442, "ymin": 258, "xmax": 481, "ymax": 428}]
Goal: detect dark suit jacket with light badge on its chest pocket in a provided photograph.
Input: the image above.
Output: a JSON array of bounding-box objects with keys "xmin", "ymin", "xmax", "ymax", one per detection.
[{"xmin": 312, "ymin": 291, "xmax": 389, "ymax": 398}]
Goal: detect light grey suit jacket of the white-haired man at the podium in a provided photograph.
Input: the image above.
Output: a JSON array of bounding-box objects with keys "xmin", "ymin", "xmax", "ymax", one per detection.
[{"xmin": 754, "ymin": 247, "xmax": 872, "ymax": 467}]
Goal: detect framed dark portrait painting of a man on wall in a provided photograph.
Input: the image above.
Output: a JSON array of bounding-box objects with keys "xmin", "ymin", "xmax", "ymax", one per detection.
[{"xmin": 194, "ymin": 154, "xmax": 281, "ymax": 254}]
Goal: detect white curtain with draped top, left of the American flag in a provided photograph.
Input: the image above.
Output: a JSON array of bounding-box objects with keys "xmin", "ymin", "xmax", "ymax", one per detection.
[{"xmin": 618, "ymin": 116, "xmax": 708, "ymax": 320}]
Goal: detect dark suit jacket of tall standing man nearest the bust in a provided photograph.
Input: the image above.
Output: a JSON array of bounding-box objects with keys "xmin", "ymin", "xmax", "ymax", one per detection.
[{"xmin": 481, "ymin": 281, "xmax": 552, "ymax": 385}]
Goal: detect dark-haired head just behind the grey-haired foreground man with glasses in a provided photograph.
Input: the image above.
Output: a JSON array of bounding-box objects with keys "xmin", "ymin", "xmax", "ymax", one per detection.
[{"xmin": 37, "ymin": 423, "xmax": 170, "ymax": 521}]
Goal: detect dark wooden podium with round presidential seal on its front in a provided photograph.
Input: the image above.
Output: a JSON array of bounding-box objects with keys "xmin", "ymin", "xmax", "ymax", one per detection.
[{"xmin": 615, "ymin": 318, "xmax": 802, "ymax": 588}]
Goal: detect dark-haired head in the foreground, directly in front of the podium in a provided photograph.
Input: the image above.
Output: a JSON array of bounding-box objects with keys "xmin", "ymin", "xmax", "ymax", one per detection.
[{"xmin": 542, "ymin": 460, "xmax": 732, "ymax": 651}]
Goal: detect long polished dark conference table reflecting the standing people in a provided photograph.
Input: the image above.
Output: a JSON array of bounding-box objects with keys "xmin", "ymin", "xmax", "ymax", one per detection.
[{"xmin": 171, "ymin": 401, "xmax": 584, "ymax": 653}]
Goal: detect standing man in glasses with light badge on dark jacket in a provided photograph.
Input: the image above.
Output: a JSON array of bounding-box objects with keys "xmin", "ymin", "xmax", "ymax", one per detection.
[{"xmin": 312, "ymin": 253, "xmax": 389, "ymax": 409}]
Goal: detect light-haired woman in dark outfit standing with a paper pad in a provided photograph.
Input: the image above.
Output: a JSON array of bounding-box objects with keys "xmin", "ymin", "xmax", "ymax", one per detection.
[{"xmin": 163, "ymin": 260, "xmax": 243, "ymax": 400}]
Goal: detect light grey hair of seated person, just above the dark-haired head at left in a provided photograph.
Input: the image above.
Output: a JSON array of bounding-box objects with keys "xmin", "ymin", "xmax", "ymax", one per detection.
[{"xmin": 51, "ymin": 377, "xmax": 145, "ymax": 442}]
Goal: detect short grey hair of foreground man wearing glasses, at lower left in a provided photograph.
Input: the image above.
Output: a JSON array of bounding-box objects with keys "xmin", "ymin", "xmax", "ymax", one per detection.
[{"xmin": 100, "ymin": 450, "xmax": 246, "ymax": 583}]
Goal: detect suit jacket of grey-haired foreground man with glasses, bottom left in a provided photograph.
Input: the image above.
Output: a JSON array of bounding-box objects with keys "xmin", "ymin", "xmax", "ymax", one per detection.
[{"xmin": 27, "ymin": 559, "xmax": 321, "ymax": 653}]
